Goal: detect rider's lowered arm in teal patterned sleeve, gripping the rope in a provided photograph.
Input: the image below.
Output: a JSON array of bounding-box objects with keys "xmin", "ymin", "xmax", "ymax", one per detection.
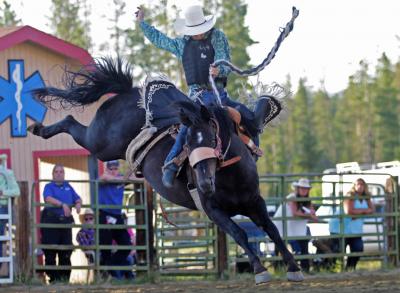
[{"xmin": 211, "ymin": 29, "xmax": 231, "ymax": 77}]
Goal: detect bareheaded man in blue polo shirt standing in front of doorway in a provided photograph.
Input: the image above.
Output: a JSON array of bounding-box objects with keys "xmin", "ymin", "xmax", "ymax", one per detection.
[{"xmin": 40, "ymin": 164, "xmax": 82, "ymax": 283}]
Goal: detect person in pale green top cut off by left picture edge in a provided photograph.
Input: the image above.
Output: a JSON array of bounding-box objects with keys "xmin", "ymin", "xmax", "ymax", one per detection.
[{"xmin": 0, "ymin": 154, "xmax": 20, "ymax": 268}]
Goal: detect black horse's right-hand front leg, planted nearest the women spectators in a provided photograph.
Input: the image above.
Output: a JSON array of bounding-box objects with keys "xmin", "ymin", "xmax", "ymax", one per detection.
[{"xmin": 248, "ymin": 197, "xmax": 304, "ymax": 281}]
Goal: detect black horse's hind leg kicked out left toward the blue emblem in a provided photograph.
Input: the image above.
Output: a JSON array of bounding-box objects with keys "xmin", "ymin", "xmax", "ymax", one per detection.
[{"xmin": 28, "ymin": 115, "xmax": 89, "ymax": 149}]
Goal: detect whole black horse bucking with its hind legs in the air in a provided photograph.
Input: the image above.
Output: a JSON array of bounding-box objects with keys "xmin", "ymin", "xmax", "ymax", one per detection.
[{"xmin": 29, "ymin": 58, "xmax": 304, "ymax": 284}]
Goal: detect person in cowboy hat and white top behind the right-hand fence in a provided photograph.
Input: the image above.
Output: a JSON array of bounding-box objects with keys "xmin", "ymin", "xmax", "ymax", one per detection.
[{"xmin": 274, "ymin": 178, "xmax": 318, "ymax": 272}]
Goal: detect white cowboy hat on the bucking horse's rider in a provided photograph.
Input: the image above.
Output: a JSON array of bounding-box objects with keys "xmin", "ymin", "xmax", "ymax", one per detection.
[{"xmin": 174, "ymin": 5, "xmax": 216, "ymax": 36}]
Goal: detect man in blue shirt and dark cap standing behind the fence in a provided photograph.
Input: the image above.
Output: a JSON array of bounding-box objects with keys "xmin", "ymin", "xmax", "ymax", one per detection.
[{"xmin": 99, "ymin": 160, "xmax": 131, "ymax": 279}]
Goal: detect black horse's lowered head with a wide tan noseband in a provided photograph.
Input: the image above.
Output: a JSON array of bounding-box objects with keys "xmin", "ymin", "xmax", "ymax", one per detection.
[{"xmin": 180, "ymin": 103, "xmax": 221, "ymax": 195}]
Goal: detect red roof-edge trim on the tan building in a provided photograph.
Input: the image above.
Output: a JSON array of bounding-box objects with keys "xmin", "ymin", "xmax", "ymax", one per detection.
[{"xmin": 0, "ymin": 25, "xmax": 93, "ymax": 65}]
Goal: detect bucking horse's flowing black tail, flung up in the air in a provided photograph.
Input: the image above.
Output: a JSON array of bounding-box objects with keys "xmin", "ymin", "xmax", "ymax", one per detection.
[{"xmin": 33, "ymin": 57, "xmax": 133, "ymax": 108}]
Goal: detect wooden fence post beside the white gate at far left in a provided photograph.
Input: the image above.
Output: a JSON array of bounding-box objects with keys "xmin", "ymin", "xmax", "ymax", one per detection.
[{"xmin": 14, "ymin": 181, "xmax": 31, "ymax": 281}]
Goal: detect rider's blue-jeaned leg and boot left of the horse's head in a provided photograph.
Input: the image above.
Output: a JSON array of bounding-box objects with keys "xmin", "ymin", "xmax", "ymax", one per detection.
[{"xmin": 162, "ymin": 125, "xmax": 187, "ymax": 187}]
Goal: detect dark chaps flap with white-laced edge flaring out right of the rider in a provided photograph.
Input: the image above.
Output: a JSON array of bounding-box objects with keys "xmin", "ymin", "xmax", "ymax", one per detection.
[{"xmin": 253, "ymin": 96, "xmax": 282, "ymax": 133}]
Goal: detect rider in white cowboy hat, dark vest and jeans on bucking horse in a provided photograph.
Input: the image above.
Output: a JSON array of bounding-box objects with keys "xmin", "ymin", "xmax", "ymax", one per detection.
[{"xmin": 136, "ymin": 5, "xmax": 269, "ymax": 187}]
